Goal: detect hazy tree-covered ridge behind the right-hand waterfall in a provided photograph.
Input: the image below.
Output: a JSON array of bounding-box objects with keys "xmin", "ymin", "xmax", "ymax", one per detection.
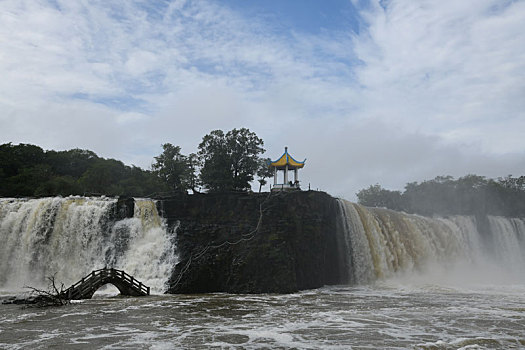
[{"xmin": 357, "ymin": 174, "xmax": 525, "ymax": 217}]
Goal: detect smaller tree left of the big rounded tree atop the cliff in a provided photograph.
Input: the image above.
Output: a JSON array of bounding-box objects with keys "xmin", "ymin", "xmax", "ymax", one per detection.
[{"xmin": 151, "ymin": 143, "xmax": 195, "ymax": 192}]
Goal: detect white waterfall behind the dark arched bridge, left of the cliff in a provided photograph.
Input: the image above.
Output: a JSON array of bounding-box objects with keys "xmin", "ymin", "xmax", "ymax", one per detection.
[{"xmin": 0, "ymin": 197, "xmax": 176, "ymax": 293}]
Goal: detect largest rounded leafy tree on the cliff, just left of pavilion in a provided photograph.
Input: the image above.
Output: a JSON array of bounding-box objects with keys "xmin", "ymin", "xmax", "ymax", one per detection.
[{"xmin": 198, "ymin": 128, "xmax": 264, "ymax": 192}]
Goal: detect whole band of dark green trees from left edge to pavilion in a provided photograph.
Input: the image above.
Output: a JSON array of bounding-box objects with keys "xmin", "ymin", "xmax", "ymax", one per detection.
[{"xmin": 0, "ymin": 128, "xmax": 273, "ymax": 197}]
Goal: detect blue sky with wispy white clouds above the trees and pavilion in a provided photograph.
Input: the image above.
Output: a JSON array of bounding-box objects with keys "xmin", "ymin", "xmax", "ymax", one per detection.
[{"xmin": 0, "ymin": 0, "xmax": 525, "ymax": 200}]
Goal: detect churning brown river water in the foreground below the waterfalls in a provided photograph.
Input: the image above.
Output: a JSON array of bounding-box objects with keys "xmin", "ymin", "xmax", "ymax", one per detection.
[{"xmin": 0, "ymin": 281, "xmax": 525, "ymax": 349}]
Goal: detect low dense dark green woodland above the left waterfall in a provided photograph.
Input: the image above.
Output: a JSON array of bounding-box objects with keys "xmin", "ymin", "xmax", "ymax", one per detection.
[{"xmin": 0, "ymin": 143, "xmax": 168, "ymax": 197}]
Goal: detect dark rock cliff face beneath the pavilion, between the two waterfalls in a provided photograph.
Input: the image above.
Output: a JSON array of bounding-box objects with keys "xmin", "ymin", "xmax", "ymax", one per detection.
[{"xmin": 158, "ymin": 191, "xmax": 341, "ymax": 293}]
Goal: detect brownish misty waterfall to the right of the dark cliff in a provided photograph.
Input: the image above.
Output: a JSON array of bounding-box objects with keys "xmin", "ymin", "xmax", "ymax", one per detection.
[{"xmin": 338, "ymin": 199, "xmax": 525, "ymax": 284}]
